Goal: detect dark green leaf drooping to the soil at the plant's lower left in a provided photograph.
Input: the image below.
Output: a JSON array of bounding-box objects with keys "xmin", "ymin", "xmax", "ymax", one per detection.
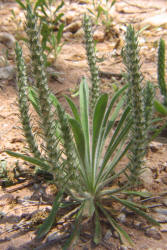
[{"xmin": 36, "ymin": 189, "xmax": 64, "ymax": 239}]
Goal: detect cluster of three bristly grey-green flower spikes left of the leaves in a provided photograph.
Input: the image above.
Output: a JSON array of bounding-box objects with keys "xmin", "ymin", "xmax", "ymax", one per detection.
[{"xmin": 16, "ymin": 1, "xmax": 73, "ymax": 183}]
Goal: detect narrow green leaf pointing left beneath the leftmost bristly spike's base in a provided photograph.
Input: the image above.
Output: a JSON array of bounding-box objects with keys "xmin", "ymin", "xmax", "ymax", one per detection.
[{"xmin": 5, "ymin": 150, "xmax": 50, "ymax": 170}]
